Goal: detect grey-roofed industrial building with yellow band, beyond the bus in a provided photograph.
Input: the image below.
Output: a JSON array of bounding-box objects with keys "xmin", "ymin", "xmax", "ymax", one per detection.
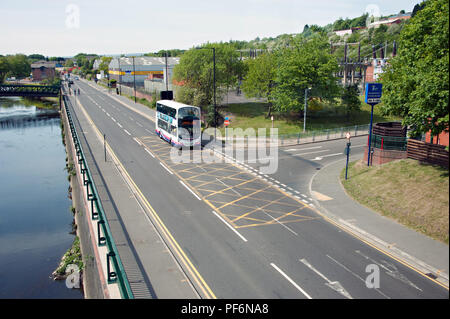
[{"xmin": 109, "ymin": 56, "xmax": 180, "ymax": 87}]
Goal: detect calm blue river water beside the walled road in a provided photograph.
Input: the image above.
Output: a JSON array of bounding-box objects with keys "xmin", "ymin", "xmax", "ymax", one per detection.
[{"xmin": 0, "ymin": 98, "xmax": 83, "ymax": 298}]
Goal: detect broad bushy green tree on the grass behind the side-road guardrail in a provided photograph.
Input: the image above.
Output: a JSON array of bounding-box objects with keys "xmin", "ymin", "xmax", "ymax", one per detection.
[{"xmin": 272, "ymin": 34, "xmax": 339, "ymax": 112}]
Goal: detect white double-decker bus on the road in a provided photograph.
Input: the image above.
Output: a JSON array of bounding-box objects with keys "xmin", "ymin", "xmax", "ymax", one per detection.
[{"xmin": 155, "ymin": 100, "xmax": 201, "ymax": 147}]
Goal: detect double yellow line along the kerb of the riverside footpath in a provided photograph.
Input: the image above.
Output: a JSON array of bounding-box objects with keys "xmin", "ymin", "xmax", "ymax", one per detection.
[{"xmin": 77, "ymin": 100, "xmax": 217, "ymax": 299}]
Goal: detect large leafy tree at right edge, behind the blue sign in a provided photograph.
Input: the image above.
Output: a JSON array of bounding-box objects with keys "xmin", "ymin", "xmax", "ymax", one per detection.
[{"xmin": 382, "ymin": 0, "xmax": 449, "ymax": 139}]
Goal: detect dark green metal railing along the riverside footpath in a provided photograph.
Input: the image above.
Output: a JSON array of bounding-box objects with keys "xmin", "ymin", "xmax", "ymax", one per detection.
[{"xmin": 64, "ymin": 96, "xmax": 134, "ymax": 299}]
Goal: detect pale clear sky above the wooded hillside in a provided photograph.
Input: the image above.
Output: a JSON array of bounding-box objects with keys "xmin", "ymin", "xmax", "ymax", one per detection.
[{"xmin": 0, "ymin": 0, "xmax": 421, "ymax": 57}]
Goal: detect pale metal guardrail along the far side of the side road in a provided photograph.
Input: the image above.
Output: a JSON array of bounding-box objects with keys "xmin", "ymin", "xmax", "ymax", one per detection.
[{"xmin": 278, "ymin": 124, "xmax": 369, "ymax": 145}]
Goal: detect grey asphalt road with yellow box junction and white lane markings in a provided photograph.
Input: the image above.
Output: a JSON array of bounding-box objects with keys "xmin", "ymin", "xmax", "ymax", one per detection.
[{"xmin": 68, "ymin": 81, "xmax": 448, "ymax": 299}]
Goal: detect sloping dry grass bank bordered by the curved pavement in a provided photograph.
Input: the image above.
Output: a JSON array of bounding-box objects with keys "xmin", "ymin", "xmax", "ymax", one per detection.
[{"xmin": 340, "ymin": 159, "xmax": 449, "ymax": 245}]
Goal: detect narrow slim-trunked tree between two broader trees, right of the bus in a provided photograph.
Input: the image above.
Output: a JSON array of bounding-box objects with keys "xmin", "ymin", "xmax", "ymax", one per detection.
[{"xmin": 242, "ymin": 53, "xmax": 276, "ymax": 117}]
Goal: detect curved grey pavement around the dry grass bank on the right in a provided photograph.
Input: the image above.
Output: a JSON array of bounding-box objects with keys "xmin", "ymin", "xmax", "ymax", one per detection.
[{"xmin": 309, "ymin": 155, "xmax": 449, "ymax": 288}]
